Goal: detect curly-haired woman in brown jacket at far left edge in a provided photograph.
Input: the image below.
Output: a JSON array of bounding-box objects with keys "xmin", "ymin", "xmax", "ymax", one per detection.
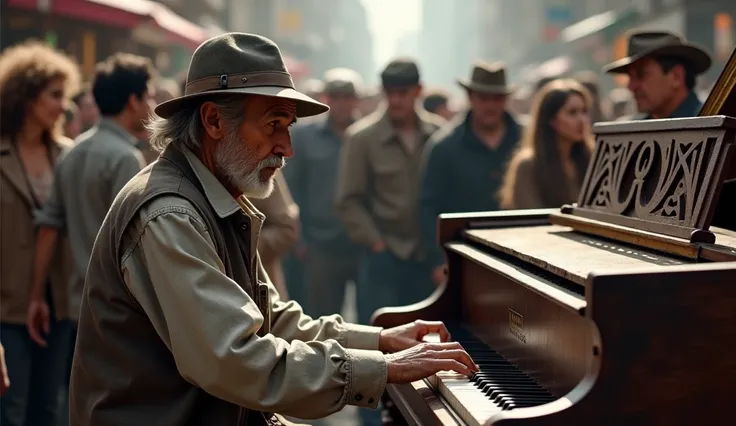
[{"xmin": 0, "ymin": 42, "xmax": 79, "ymax": 426}]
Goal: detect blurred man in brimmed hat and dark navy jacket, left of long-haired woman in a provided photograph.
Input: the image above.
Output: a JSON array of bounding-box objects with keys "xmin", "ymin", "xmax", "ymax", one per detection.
[{"xmin": 419, "ymin": 63, "xmax": 521, "ymax": 284}]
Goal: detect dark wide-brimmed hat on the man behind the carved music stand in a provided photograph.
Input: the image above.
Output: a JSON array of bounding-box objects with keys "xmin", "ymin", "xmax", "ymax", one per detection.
[{"xmin": 603, "ymin": 31, "xmax": 711, "ymax": 74}]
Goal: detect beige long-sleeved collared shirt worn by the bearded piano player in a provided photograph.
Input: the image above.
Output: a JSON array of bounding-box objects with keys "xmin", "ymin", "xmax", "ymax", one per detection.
[{"xmin": 120, "ymin": 146, "xmax": 387, "ymax": 418}]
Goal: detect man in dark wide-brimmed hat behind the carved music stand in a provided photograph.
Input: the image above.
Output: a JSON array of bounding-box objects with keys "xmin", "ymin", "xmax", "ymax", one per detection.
[{"xmin": 604, "ymin": 31, "xmax": 711, "ymax": 120}]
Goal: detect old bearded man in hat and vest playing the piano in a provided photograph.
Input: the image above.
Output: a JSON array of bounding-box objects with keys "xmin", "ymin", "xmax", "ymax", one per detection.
[{"xmin": 70, "ymin": 33, "xmax": 476, "ymax": 426}]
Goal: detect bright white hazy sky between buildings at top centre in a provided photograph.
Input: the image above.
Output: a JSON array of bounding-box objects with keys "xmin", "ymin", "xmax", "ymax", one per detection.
[{"xmin": 362, "ymin": 0, "xmax": 420, "ymax": 68}]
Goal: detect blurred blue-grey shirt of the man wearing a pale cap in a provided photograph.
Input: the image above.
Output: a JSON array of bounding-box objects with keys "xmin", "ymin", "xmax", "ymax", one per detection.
[{"xmin": 284, "ymin": 119, "xmax": 353, "ymax": 250}]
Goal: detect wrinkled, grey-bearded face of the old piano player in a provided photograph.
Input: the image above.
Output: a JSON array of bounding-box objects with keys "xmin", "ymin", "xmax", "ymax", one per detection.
[{"xmin": 214, "ymin": 96, "xmax": 296, "ymax": 198}]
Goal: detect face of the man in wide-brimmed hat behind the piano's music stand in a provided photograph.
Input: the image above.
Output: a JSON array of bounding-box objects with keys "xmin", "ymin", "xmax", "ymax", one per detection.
[{"xmin": 628, "ymin": 58, "xmax": 683, "ymax": 114}]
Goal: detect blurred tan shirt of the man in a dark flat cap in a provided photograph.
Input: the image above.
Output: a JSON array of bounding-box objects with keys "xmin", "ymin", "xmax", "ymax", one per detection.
[{"xmin": 335, "ymin": 109, "xmax": 445, "ymax": 259}]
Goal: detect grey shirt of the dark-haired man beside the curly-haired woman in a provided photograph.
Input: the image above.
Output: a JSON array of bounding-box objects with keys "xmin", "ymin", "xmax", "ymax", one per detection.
[{"xmin": 35, "ymin": 118, "xmax": 145, "ymax": 317}]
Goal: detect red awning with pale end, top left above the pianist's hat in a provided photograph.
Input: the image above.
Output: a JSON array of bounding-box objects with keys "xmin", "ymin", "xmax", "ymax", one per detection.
[{"xmin": 8, "ymin": 0, "xmax": 207, "ymax": 49}]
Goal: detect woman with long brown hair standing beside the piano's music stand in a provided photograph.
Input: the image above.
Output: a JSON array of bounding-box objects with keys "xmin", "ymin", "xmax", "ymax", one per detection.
[{"xmin": 499, "ymin": 79, "xmax": 593, "ymax": 209}]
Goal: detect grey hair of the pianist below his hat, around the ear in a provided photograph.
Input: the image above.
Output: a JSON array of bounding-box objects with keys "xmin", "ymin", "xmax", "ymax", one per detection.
[{"xmin": 146, "ymin": 95, "xmax": 245, "ymax": 152}]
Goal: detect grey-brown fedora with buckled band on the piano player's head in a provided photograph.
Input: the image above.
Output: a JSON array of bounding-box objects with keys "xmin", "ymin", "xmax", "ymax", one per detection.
[{"xmin": 154, "ymin": 33, "xmax": 330, "ymax": 118}]
